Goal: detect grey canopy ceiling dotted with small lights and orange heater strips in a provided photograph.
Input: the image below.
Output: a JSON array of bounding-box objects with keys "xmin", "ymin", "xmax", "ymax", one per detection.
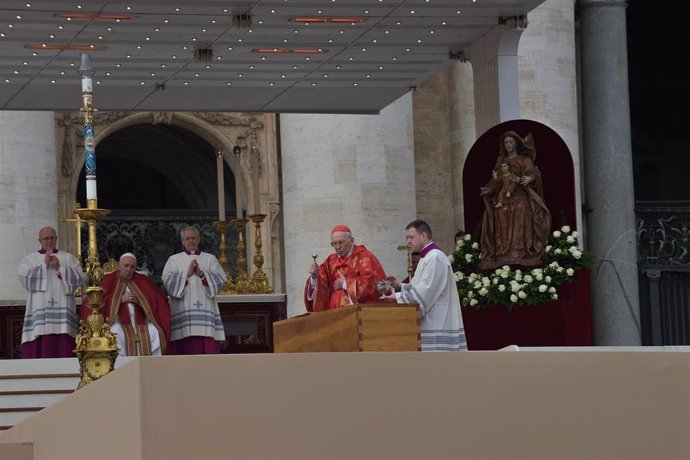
[{"xmin": 0, "ymin": 0, "xmax": 543, "ymax": 113}]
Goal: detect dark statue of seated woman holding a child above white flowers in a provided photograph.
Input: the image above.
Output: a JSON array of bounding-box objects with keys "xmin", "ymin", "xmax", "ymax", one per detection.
[{"xmin": 479, "ymin": 131, "xmax": 551, "ymax": 269}]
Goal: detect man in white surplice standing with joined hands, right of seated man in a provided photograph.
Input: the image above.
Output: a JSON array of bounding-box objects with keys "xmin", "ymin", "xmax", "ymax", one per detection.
[{"xmin": 162, "ymin": 227, "xmax": 226, "ymax": 355}]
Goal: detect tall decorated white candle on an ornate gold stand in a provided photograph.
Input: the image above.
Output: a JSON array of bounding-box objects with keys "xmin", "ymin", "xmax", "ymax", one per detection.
[{"xmin": 74, "ymin": 53, "xmax": 117, "ymax": 388}]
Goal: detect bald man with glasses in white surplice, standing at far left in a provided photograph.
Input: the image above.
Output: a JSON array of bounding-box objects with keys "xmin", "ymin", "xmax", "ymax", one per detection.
[{"xmin": 18, "ymin": 227, "xmax": 84, "ymax": 358}]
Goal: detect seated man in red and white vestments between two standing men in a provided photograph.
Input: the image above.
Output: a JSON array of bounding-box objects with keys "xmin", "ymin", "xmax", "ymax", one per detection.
[{"xmin": 81, "ymin": 253, "xmax": 170, "ymax": 356}]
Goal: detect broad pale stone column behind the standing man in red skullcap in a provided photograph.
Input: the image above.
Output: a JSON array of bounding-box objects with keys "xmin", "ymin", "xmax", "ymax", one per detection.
[{"xmin": 280, "ymin": 94, "xmax": 416, "ymax": 316}]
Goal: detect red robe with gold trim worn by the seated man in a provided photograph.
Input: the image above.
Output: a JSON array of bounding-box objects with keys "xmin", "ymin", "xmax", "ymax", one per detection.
[{"xmin": 81, "ymin": 272, "xmax": 170, "ymax": 355}]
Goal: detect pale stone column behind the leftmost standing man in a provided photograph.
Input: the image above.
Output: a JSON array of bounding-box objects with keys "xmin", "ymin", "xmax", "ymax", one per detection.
[{"xmin": 0, "ymin": 111, "xmax": 60, "ymax": 305}]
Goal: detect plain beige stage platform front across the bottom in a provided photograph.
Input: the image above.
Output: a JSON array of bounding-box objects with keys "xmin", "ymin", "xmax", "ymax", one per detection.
[{"xmin": 0, "ymin": 348, "xmax": 690, "ymax": 460}]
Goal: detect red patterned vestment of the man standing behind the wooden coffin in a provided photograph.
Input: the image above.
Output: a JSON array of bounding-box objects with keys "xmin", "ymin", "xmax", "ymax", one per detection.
[{"xmin": 304, "ymin": 244, "xmax": 386, "ymax": 311}]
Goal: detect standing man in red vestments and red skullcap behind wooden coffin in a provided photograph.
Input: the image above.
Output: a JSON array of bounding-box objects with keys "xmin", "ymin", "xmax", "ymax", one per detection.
[{"xmin": 304, "ymin": 225, "xmax": 386, "ymax": 312}]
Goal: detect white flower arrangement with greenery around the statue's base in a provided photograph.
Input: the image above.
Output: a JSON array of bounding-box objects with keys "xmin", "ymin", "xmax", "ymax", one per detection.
[{"xmin": 448, "ymin": 225, "xmax": 588, "ymax": 310}]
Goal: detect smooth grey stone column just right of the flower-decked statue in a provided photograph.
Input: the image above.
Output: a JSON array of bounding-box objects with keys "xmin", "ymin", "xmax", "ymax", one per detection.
[{"xmin": 579, "ymin": 0, "xmax": 641, "ymax": 345}]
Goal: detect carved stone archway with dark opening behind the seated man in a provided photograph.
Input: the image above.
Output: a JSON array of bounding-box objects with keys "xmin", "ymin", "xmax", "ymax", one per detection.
[{"xmin": 56, "ymin": 112, "xmax": 282, "ymax": 292}]
